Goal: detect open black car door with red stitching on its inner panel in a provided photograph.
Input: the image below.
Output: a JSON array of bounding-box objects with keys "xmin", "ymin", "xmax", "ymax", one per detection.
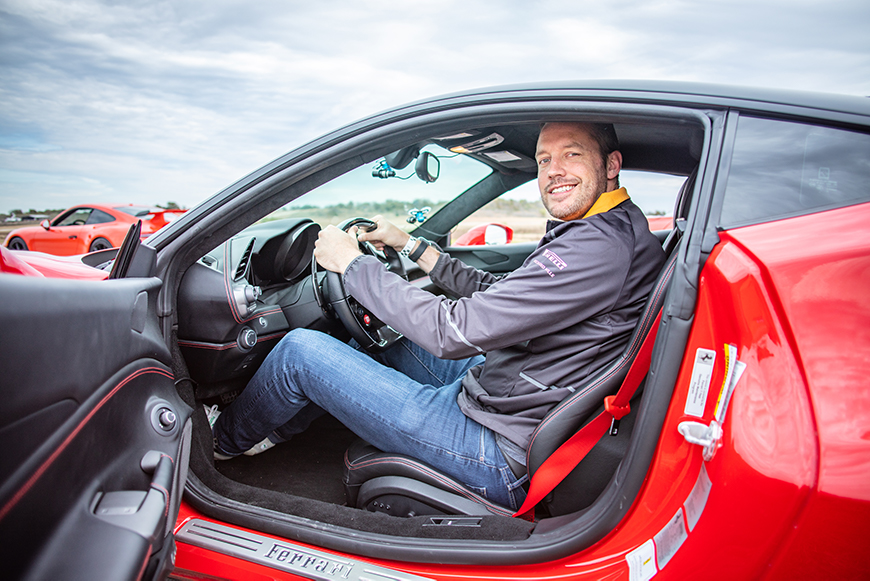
[{"xmin": 0, "ymin": 275, "xmax": 191, "ymax": 579}]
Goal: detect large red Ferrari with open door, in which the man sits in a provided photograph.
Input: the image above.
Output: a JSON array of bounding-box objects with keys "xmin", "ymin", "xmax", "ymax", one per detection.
[{"xmin": 0, "ymin": 81, "xmax": 870, "ymax": 581}]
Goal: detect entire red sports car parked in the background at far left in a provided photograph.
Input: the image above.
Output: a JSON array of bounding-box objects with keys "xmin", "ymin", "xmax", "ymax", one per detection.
[{"xmin": 4, "ymin": 204, "xmax": 185, "ymax": 256}]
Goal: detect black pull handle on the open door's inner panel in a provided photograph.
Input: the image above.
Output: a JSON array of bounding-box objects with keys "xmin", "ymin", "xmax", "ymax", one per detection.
[{"xmin": 94, "ymin": 450, "xmax": 173, "ymax": 544}]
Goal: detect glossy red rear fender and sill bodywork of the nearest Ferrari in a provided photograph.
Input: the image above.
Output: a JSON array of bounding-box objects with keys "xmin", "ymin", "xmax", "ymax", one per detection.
[{"xmin": 175, "ymin": 204, "xmax": 870, "ymax": 580}]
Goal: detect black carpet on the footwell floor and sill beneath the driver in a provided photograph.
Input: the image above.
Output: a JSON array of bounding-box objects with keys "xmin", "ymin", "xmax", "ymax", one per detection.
[{"xmin": 190, "ymin": 402, "xmax": 535, "ymax": 546}]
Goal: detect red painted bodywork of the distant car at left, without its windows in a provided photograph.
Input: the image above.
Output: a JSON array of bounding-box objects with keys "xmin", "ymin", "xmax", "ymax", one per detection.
[{"xmin": 3, "ymin": 204, "xmax": 186, "ymax": 256}]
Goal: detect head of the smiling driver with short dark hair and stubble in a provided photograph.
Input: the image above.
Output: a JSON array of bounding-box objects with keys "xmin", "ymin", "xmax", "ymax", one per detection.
[{"xmin": 535, "ymin": 123, "xmax": 622, "ymax": 220}]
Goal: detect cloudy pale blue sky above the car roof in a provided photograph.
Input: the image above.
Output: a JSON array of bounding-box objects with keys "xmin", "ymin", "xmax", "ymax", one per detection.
[{"xmin": 0, "ymin": 0, "xmax": 870, "ymax": 213}]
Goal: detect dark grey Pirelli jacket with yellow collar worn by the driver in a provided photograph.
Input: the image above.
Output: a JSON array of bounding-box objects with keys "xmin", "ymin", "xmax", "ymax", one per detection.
[{"xmin": 344, "ymin": 189, "xmax": 665, "ymax": 460}]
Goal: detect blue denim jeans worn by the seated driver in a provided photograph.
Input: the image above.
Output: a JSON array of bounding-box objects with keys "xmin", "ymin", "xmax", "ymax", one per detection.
[{"xmin": 214, "ymin": 329, "xmax": 526, "ymax": 510}]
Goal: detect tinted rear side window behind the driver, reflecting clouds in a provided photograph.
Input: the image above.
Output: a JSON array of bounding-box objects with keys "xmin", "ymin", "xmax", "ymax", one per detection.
[{"xmin": 719, "ymin": 117, "xmax": 870, "ymax": 228}]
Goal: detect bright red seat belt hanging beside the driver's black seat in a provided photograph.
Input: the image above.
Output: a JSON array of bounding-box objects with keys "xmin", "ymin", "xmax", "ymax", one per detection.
[{"xmin": 513, "ymin": 311, "xmax": 662, "ymax": 521}]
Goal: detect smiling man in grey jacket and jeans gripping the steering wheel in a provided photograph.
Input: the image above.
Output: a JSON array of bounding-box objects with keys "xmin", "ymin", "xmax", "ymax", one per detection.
[{"xmin": 214, "ymin": 123, "xmax": 664, "ymax": 510}]
